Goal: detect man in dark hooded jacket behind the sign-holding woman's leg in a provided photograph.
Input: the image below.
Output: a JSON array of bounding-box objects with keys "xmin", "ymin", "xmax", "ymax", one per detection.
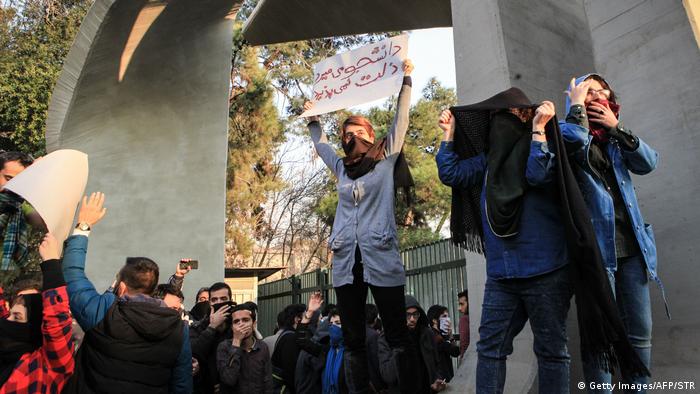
[{"xmin": 379, "ymin": 295, "xmax": 447, "ymax": 394}]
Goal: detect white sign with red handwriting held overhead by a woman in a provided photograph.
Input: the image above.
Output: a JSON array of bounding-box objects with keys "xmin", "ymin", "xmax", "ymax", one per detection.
[{"xmin": 301, "ymin": 34, "xmax": 408, "ymax": 117}]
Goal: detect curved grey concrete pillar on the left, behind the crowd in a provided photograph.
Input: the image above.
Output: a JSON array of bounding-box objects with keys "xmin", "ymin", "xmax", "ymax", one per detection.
[{"xmin": 47, "ymin": 0, "xmax": 234, "ymax": 305}]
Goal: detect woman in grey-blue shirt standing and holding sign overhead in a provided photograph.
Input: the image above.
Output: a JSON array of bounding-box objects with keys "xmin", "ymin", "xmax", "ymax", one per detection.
[{"xmin": 304, "ymin": 60, "xmax": 417, "ymax": 393}]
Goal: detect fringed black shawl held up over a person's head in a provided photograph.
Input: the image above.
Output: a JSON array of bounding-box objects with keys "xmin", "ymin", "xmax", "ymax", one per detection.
[{"xmin": 451, "ymin": 88, "xmax": 650, "ymax": 377}]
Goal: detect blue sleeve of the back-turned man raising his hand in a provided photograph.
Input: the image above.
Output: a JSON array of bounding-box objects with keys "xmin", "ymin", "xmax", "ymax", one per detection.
[{"xmin": 63, "ymin": 235, "xmax": 116, "ymax": 332}]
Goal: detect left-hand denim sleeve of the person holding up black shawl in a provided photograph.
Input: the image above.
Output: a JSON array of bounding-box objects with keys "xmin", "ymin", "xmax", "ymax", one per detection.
[{"xmin": 435, "ymin": 141, "xmax": 486, "ymax": 189}]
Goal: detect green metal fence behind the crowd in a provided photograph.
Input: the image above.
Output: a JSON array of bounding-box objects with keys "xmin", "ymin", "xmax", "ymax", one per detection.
[{"xmin": 257, "ymin": 239, "xmax": 467, "ymax": 336}]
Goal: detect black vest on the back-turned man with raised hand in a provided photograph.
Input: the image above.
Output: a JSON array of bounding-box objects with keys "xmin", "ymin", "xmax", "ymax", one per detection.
[{"xmin": 64, "ymin": 301, "xmax": 185, "ymax": 394}]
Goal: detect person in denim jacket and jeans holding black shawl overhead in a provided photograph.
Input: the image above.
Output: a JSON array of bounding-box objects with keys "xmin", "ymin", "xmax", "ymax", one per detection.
[{"xmin": 436, "ymin": 88, "xmax": 572, "ymax": 393}]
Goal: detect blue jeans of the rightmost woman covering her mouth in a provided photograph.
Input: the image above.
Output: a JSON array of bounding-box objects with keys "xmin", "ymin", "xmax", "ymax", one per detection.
[{"xmin": 583, "ymin": 256, "xmax": 651, "ymax": 394}]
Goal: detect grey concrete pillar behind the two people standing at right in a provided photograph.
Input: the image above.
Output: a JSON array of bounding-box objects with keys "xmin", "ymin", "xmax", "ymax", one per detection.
[{"xmin": 451, "ymin": 0, "xmax": 700, "ymax": 393}]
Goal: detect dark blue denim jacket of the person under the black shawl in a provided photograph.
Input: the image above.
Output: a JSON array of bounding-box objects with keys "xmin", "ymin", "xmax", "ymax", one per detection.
[{"xmin": 435, "ymin": 141, "xmax": 567, "ymax": 279}]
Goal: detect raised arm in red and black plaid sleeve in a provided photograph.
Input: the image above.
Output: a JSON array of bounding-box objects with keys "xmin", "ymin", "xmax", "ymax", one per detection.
[{"xmin": 39, "ymin": 233, "xmax": 75, "ymax": 382}]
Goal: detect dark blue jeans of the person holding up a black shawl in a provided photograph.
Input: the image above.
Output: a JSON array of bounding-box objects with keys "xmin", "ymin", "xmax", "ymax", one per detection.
[{"xmin": 476, "ymin": 267, "xmax": 572, "ymax": 394}]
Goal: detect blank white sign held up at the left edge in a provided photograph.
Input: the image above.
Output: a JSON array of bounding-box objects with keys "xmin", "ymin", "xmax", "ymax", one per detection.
[{"xmin": 5, "ymin": 149, "xmax": 88, "ymax": 248}]
